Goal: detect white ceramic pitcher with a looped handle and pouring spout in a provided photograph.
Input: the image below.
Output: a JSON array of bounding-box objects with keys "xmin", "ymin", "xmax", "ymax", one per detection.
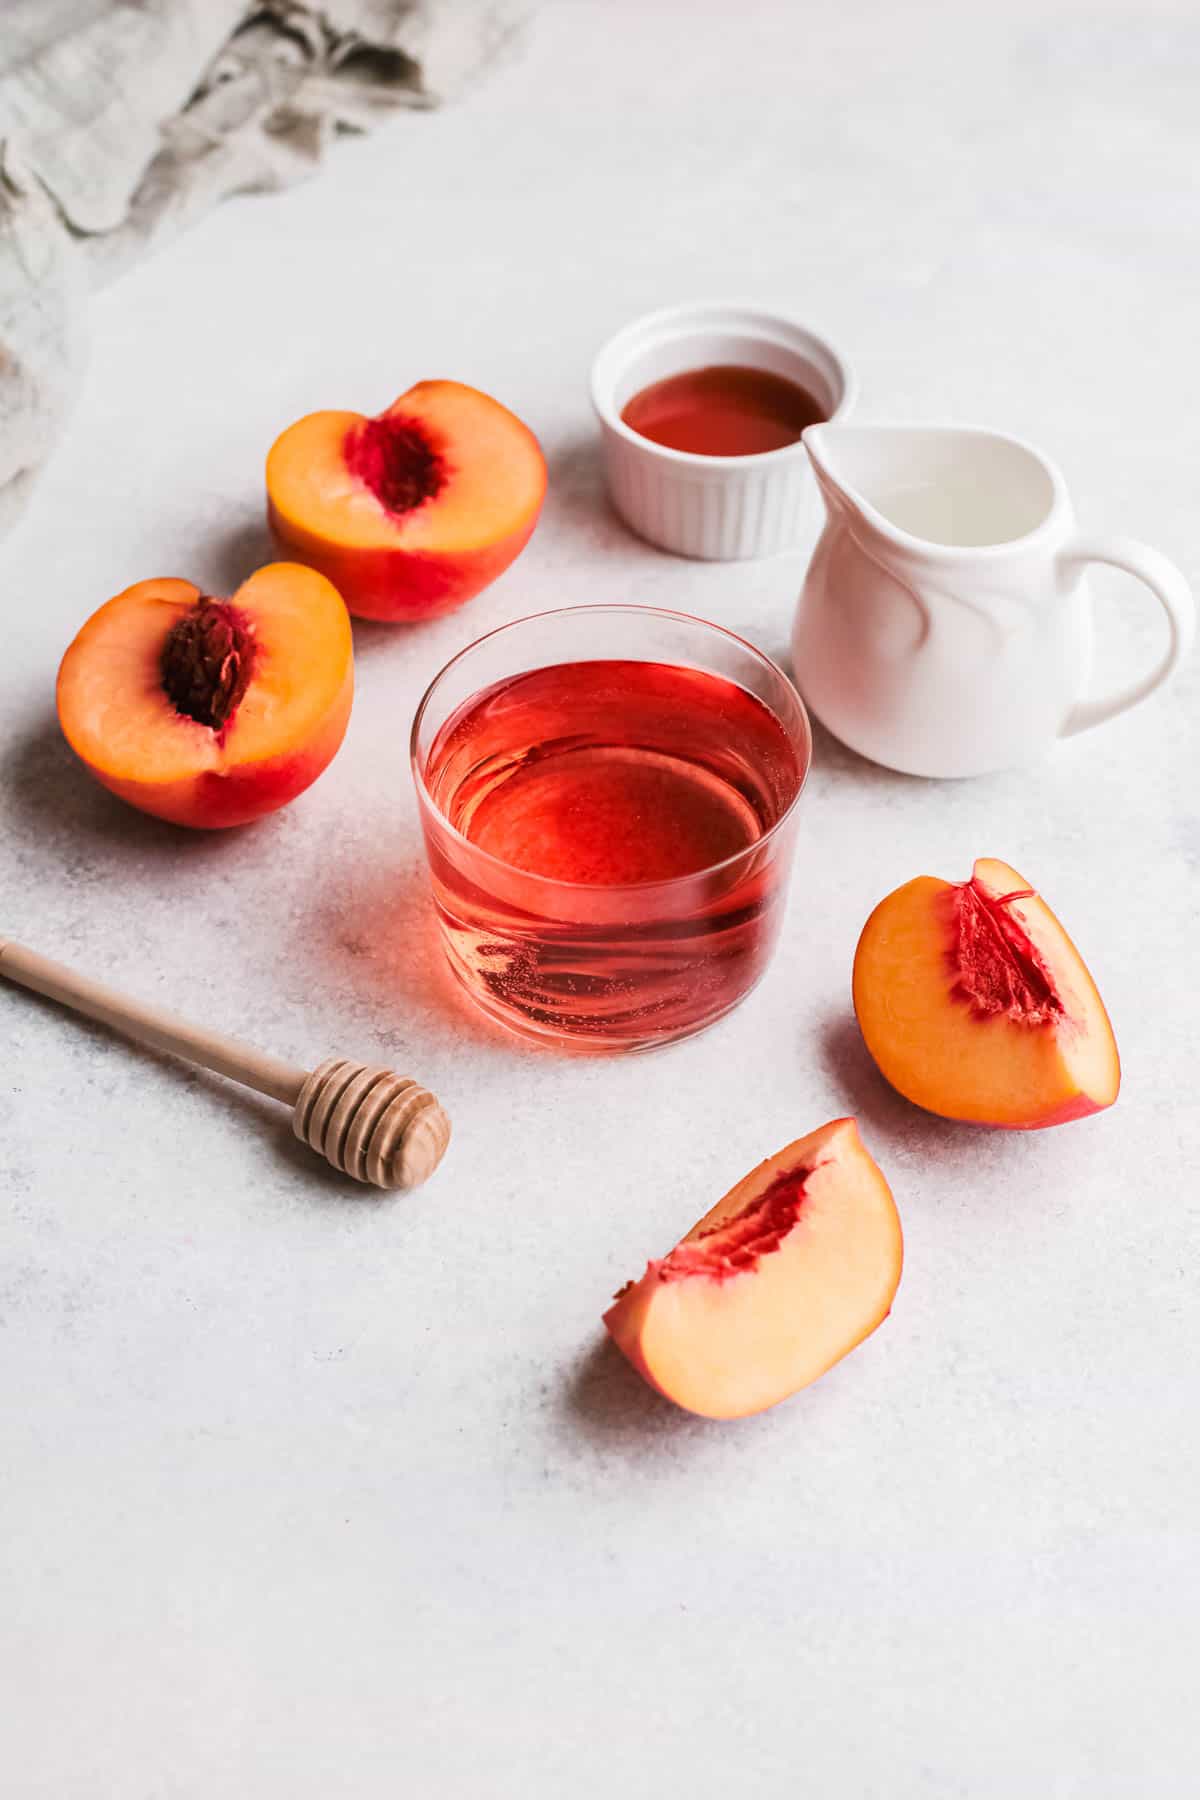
[{"xmin": 792, "ymin": 425, "xmax": 1195, "ymax": 776}]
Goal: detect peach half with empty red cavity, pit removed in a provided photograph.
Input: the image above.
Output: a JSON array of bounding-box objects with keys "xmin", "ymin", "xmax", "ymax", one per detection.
[{"xmin": 266, "ymin": 382, "xmax": 545, "ymax": 621}]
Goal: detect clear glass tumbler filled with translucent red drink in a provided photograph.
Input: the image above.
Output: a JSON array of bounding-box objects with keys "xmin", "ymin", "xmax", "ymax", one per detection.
[{"xmin": 412, "ymin": 605, "xmax": 811, "ymax": 1051}]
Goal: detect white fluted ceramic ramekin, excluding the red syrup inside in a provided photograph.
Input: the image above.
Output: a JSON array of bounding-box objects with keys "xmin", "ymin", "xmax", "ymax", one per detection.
[{"xmin": 592, "ymin": 302, "xmax": 856, "ymax": 562}]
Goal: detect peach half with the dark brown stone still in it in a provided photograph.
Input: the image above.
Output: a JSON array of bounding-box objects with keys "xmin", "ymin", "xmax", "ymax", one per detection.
[{"xmin": 58, "ymin": 563, "xmax": 354, "ymax": 826}]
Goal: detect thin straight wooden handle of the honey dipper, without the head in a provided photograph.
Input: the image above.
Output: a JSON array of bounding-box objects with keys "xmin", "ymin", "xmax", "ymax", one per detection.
[{"xmin": 0, "ymin": 941, "xmax": 308, "ymax": 1107}]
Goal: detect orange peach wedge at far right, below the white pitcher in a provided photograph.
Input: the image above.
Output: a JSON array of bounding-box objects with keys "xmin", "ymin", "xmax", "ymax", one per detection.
[{"xmin": 855, "ymin": 857, "xmax": 1121, "ymax": 1130}]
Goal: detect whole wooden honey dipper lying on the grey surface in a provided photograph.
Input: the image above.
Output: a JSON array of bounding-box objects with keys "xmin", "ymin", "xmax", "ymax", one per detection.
[{"xmin": 0, "ymin": 941, "xmax": 450, "ymax": 1188}]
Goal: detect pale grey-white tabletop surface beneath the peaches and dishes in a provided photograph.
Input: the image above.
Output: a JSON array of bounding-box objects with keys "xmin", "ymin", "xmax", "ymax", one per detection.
[{"xmin": 0, "ymin": 0, "xmax": 1200, "ymax": 1800}]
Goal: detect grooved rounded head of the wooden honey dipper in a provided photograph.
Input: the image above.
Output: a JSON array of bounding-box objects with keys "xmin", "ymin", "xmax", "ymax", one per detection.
[{"xmin": 291, "ymin": 1057, "xmax": 450, "ymax": 1188}]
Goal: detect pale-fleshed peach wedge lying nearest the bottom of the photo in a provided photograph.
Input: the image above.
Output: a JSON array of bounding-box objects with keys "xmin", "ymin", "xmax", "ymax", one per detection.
[{"xmin": 604, "ymin": 1120, "xmax": 903, "ymax": 1418}]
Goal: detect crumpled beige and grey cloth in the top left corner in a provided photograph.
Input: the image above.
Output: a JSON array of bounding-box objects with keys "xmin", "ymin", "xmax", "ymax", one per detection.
[{"xmin": 0, "ymin": 0, "xmax": 529, "ymax": 531}]
